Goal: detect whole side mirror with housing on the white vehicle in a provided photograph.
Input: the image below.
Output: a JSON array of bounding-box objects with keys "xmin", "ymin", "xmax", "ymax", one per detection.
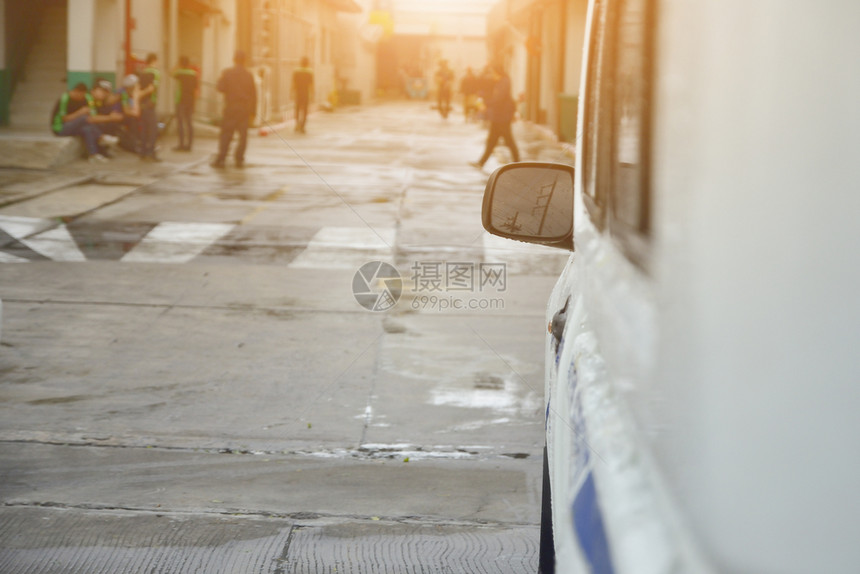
[{"xmin": 481, "ymin": 162, "xmax": 574, "ymax": 251}]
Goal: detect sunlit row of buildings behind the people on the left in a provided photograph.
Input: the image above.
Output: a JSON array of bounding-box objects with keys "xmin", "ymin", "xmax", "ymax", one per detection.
[{"xmin": 0, "ymin": 0, "xmax": 375, "ymax": 130}]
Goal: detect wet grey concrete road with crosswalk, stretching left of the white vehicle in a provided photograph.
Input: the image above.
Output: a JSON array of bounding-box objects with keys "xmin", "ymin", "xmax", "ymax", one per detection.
[{"xmin": 0, "ymin": 103, "xmax": 569, "ymax": 573}]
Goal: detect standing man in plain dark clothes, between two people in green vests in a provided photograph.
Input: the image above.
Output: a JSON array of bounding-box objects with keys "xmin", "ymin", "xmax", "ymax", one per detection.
[{"xmin": 212, "ymin": 50, "xmax": 257, "ymax": 168}]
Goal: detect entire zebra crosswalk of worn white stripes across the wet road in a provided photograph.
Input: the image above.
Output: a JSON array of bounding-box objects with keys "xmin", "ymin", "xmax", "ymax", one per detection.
[{"xmin": 0, "ymin": 222, "xmax": 569, "ymax": 273}]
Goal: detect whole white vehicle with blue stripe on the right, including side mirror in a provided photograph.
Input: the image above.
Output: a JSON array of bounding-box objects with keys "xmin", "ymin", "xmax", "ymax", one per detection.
[{"xmin": 483, "ymin": 0, "xmax": 860, "ymax": 574}]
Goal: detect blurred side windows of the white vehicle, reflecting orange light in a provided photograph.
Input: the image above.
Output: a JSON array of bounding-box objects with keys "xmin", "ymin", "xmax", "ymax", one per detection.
[{"xmin": 582, "ymin": 0, "xmax": 653, "ymax": 265}]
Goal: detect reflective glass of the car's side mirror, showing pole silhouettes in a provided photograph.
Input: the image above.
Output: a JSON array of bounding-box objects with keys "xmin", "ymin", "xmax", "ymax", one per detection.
[{"xmin": 491, "ymin": 166, "xmax": 573, "ymax": 241}]
